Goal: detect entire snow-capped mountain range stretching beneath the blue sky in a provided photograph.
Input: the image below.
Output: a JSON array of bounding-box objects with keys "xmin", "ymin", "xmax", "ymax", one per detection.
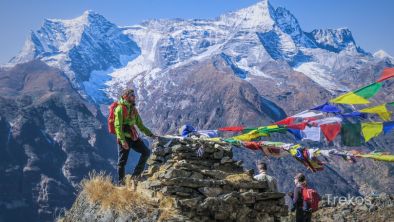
[{"xmin": 11, "ymin": 0, "xmax": 390, "ymax": 104}]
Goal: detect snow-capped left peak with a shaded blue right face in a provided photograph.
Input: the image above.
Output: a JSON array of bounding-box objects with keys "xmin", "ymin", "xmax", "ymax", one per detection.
[{"xmin": 10, "ymin": 11, "xmax": 141, "ymax": 103}]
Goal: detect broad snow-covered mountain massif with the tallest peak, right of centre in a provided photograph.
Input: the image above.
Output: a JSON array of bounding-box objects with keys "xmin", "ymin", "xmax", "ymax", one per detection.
[{"xmin": 108, "ymin": 1, "xmax": 390, "ymax": 103}]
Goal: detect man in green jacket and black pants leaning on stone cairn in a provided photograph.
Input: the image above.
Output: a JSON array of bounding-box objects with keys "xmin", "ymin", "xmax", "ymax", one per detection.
[{"xmin": 110, "ymin": 89, "xmax": 157, "ymax": 185}]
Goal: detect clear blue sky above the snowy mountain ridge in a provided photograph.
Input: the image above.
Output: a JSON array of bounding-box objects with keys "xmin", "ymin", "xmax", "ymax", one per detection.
[{"xmin": 0, "ymin": 0, "xmax": 394, "ymax": 64}]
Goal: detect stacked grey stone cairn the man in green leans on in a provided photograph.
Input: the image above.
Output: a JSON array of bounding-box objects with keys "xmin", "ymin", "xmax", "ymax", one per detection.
[{"xmin": 133, "ymin": 138, "xmax": 287, "ymax": 221}]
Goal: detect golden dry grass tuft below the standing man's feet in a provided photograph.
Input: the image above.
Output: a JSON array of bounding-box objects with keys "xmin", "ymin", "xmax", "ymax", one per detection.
[{"xmin": 81, "ymin": 172, "xmax": 154, "ymax": 212}]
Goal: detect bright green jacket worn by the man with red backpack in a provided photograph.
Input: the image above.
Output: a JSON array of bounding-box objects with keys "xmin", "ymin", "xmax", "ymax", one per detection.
[{"xmin": 114, "ymin": 98, "xmax": 153, "ymax": 143}]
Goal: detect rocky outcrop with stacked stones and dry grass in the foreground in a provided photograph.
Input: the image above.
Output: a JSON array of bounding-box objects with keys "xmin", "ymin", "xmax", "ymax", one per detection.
[{"xmin": 62, "ymin": 139, "xmax": 287, "ymax": 221}]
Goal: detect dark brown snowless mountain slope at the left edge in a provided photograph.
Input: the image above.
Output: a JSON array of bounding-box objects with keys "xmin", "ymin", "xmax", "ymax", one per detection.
[{"xmin": 0, "ymin": 61, "xmax": 116, "ymax": 221}]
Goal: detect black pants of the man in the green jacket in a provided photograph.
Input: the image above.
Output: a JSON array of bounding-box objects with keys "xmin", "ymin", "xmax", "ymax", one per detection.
[{"xmin": 118, "ymin": 138, "xmax": 150, "ymax": 183}]
